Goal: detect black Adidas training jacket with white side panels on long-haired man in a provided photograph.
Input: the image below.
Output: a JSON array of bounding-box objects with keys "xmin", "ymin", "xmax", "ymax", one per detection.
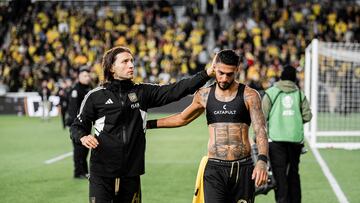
[{"xmin": 70, "ymin": 71, "xmax": 209, "ymax": 177}]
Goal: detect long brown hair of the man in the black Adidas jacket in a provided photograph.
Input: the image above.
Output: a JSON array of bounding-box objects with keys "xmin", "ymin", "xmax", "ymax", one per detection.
[{"xmin": 102, "ymin": 46, "xmax": 131, "ymax": 81}]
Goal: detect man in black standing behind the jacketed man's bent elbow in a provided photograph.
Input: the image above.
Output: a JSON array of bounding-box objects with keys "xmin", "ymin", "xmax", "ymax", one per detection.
[{"xmin": 66, "ymin": 67, "xmax": 91, "ymax": 179}]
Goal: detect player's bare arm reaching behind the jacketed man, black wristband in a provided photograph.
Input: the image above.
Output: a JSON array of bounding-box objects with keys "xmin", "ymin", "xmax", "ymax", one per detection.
[{"xmin": 147, "ymin": 90, "xmax": 205, "ymax": 129}]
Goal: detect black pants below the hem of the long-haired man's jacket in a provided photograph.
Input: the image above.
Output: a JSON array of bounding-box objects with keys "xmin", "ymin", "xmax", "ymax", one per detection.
[{"xmin": 89, "ymin": 174, "xmax": 141, "ymax": 203}]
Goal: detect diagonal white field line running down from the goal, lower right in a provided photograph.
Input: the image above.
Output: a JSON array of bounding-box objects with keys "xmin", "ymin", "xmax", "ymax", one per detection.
[{"xmin": 311, "ymin": 147, "xmax": 349, "ymax": 203}]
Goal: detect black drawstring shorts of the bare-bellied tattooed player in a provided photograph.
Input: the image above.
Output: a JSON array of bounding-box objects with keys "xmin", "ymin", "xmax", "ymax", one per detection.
[{"xmin": 204, "ymin": 156, "xmax": 255, "ymax": 203}]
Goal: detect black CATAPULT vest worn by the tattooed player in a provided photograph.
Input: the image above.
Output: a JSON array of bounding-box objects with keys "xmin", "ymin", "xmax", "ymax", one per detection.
[{"xmin": 206, "ymin": 83, "xmax": 251, "ymax": 126}]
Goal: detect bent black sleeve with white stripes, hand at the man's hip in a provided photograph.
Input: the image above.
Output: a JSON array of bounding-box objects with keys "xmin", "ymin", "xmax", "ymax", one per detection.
[{"xmin": 70, "ymin": 93, "xmax": 95, "ymax": 143}]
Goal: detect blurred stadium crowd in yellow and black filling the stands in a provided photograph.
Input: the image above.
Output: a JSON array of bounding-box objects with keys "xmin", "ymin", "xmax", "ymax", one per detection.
[{"xmin": 0, "ymin": 0, "xmax": 360, "ymax": 94}]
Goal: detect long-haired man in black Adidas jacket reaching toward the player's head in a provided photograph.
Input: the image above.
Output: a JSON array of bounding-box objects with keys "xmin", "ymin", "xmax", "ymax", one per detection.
[{"xmin": 71, "ymin": 47, "xmax": 213, "ymax": 203}]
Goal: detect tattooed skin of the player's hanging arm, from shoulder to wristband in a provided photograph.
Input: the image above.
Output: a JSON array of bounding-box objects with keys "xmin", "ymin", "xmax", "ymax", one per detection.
[{"xmin": 244, "ymin": 87, "xmax": 269, "ymax": 155}]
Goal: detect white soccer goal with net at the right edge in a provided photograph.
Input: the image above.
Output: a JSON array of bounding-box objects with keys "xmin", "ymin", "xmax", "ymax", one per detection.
[{"xmin": 304, "ymin": 39, "xmax": 360, "ymax": 149}]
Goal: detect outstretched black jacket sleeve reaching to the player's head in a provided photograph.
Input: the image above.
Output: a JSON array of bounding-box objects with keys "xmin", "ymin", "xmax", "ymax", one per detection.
[{"xmin": 143, "ymin": 70, "xmax": 210, "ymax": 108}]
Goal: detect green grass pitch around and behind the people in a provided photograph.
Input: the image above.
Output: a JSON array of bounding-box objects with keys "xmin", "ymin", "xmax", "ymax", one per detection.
[{"xmin": 0, "ymin": 115, "xmax": 360, "ymax": 203}]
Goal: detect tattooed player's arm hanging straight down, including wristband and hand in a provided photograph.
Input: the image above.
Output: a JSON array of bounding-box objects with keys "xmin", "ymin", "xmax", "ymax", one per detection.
[{"xmin": 245, "ymin": 87, "xmax": 269, "ymax": 186}]
